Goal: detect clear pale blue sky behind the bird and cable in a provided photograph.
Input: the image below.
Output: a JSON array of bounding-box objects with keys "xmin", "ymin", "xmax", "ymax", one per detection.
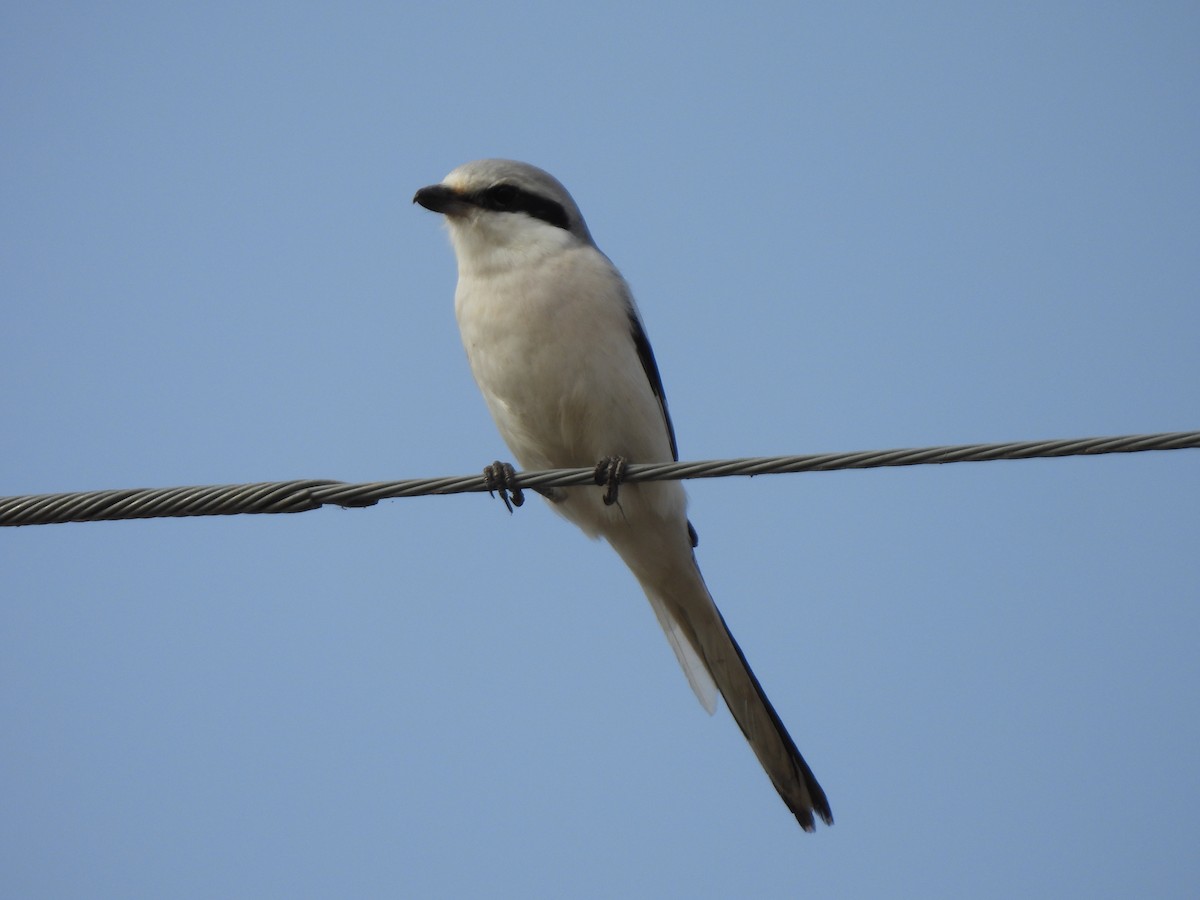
[{"xmin": 0, "ymin": 2, "xmax": 1200, "ymax": 898}]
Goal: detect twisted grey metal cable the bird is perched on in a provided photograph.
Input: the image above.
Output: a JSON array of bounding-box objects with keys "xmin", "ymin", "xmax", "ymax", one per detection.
[{"xmin": 0, "ymin": 431, "xmax": 1200, "ymax": 526}]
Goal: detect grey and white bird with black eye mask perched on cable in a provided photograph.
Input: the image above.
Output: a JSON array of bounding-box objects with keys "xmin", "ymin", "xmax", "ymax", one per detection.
[{"xmin": 413, "ymin": 160, "xmax": 833, "ymax": 832}]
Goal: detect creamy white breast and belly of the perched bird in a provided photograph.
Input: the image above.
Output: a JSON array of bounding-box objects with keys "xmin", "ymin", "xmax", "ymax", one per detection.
[{"xmin": 455, "ymin": 237, "xmax": 685, "ymax": 534}]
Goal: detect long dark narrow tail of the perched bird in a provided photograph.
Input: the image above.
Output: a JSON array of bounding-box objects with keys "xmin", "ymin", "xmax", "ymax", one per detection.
[{"xmin": 646, "ymin": 560, "xmax": 833, "ymax": 832}]
